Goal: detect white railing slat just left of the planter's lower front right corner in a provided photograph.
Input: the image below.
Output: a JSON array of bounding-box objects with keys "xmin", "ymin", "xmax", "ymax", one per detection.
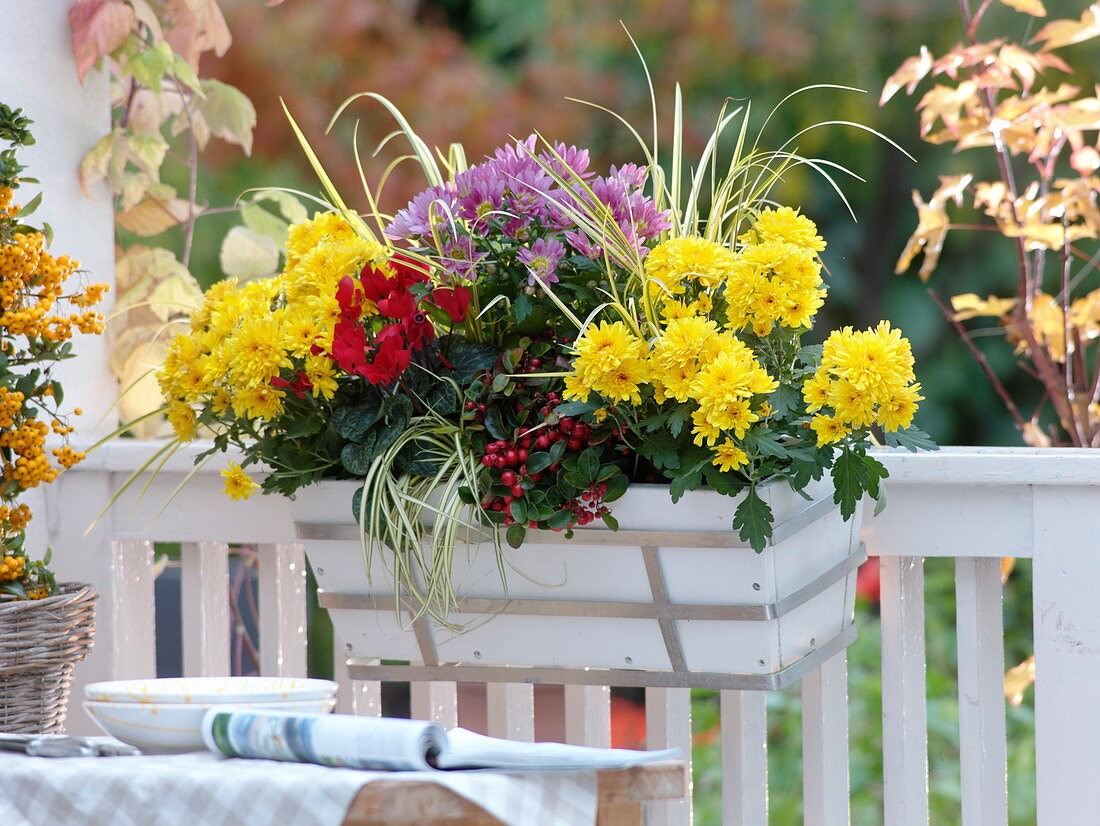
[{"xmin": 718, "ymin": 691, "xmax": 768, "ymax": 826}]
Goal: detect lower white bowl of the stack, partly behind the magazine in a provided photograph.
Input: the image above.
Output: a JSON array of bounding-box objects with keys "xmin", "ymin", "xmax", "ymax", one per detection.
[{"xmin": 84, "ymin": 696, "xmax": 337, "ymax": 755}]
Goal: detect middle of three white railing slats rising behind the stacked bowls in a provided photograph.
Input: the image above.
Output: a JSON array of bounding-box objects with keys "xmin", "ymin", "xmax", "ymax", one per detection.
[{"xmin": 179, "ymin": 541, "xmax": 231, "ymax": 676}]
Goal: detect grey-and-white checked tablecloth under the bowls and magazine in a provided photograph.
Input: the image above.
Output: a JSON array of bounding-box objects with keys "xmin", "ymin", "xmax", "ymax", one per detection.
[{"xmin": 0, "ymin": 752, "xmax": 597, "ymax": 826}]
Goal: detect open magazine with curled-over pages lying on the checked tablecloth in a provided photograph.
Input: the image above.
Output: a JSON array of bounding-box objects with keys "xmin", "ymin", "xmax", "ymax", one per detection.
[{"xmin": 202, "ymin": 707, "xmax": 680, "ymax": 771}]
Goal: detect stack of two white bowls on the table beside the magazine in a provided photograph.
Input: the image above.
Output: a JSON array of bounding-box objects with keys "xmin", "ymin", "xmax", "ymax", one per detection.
[{"xmin": 84, "ymin": 676, "xmax": 337, "ymax": 753}]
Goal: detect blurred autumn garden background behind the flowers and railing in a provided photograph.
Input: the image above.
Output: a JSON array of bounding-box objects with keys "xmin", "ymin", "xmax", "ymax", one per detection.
[{"xmin": 184, "ymin": 0, "xmax": 1078, "ymax": 826}]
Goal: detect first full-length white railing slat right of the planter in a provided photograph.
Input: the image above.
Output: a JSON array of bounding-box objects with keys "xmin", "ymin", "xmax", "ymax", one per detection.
[{"xmin": 881, "ymin": 557, "xmax": 928, "ymax": 826}]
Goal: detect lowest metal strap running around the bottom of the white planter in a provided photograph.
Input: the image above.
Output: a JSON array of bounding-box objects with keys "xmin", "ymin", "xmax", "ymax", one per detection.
[{"xmin": 348, "ymin": 625, "xmax": 856, "ymax": 691}]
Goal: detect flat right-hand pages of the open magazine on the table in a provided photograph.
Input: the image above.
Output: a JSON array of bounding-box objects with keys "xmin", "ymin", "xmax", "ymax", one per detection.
[{"xmin": 437, "ymin": 728, "xmax": 680, "ymax": 771}]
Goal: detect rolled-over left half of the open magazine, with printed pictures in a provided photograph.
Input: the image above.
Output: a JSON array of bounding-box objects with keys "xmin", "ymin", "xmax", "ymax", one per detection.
[{"xmin": 202, "ymin": 708, "xmax": 447, "ymax": 771}]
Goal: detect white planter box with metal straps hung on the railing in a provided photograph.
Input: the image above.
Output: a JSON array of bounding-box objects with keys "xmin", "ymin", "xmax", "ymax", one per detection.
[{"xmin": 293, "ymin": 481, "xmax": 862, "ymax": 689}]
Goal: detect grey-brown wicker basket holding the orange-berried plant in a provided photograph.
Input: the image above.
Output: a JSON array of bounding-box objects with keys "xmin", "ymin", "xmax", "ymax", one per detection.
[{"xmin": 0, "ymin": 582, "xmax": 97, "ymax": 734}]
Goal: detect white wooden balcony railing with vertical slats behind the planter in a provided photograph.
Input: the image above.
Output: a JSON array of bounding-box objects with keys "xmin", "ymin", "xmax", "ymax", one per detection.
[{"xmin": 21, "ymin": 441, "xmax": 1100, "ymax": 826}]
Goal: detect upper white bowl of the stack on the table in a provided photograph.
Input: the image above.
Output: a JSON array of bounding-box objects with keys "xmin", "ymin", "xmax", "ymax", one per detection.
[{"xmin": 84, "ymin": 676, "xmax": 337, "ymax": 703}]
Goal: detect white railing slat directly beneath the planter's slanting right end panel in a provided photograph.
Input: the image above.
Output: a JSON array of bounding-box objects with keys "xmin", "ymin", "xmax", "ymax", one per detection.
[{"xmin": 802, "ymin": 652, "xmax": 849, "ymax": 826}]
